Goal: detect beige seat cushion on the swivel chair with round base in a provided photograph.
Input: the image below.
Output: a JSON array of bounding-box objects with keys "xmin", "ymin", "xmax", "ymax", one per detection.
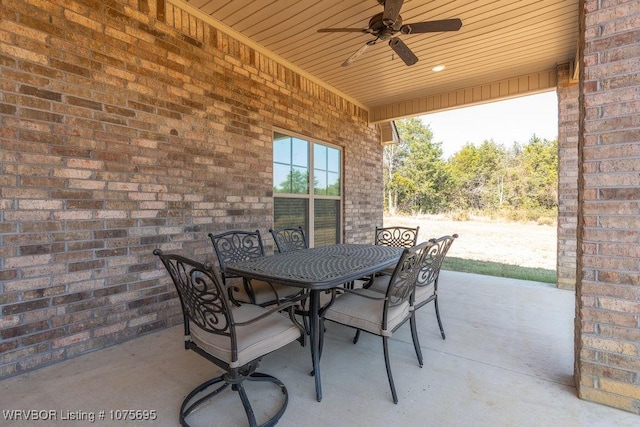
[{"xmin": 190, "ymin": 304, "xmax": 300, "ymax": 368}]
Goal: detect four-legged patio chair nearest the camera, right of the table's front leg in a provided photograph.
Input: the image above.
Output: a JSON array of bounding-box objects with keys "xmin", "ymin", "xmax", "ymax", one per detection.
[{"xmin": 324, "ymin": 242, "xmax": 427, "ymax": 403}]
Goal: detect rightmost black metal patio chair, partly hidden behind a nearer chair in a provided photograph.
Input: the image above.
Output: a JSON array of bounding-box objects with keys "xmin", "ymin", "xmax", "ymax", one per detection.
[{"xmin": 411, "ymin": 234, "xmax": 458, "ymax": 342}]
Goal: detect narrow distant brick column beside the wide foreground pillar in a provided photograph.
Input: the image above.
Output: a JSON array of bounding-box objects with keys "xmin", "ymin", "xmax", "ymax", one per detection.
[{"xmin": 557, "ymin": 63, "xmax": 579, "ymax": 290}]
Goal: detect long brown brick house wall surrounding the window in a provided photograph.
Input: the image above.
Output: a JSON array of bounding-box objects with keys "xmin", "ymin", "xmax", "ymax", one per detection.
[{"xmin": 0, "ymin": 0, "xmax": 382, "ymax": 377}]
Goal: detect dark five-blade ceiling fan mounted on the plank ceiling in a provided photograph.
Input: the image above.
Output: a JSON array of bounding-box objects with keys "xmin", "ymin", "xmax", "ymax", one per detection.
[{"xmin": 318, "ymin": 0, "xmax": 462, "ymax": 67}]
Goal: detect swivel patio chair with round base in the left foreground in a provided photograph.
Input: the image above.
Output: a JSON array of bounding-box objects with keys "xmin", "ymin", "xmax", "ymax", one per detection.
[{"xmin": 153, "ymin": 249, "xmax": 301, "ymax": 427}]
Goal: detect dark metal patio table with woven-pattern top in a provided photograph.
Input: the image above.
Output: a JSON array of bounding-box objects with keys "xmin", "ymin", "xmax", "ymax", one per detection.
[{"xmin": 225, "ymin": 244, "xmax": 403, "ymax": 402}]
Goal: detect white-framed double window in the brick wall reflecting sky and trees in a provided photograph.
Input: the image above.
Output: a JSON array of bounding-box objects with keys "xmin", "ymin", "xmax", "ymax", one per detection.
[{"xmin": 273, "ymin": 132, "xmax": 342, "ymax": 246}]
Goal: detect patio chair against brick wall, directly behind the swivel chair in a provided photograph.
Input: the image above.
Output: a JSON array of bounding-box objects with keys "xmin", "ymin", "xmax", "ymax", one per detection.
[{"xmin": 209, "ymin": 230, "xmax": 302, "ymax": 307}]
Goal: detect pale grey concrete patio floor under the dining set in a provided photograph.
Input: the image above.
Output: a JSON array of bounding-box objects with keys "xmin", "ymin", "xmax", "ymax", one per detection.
[{"xmin": 0, "ymin": 271, "xmax": 640, "ymax": 427}]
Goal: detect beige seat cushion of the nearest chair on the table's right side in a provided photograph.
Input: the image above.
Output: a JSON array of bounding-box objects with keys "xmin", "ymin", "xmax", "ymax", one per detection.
[{"xmin": 324, "ymin": 289, "xmax": 410, "ymax": 336}]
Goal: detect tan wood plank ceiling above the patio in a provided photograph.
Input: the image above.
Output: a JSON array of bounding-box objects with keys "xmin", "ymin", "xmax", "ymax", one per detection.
[{"xmin": 183, "ymin": 0, "xmax": 579, "ymax": 121}]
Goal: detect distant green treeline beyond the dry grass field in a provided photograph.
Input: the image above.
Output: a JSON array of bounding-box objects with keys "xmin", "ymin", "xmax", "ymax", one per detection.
[{"xmin": 384, "ymin": 118, "xmax": 558, "ymax": 219}]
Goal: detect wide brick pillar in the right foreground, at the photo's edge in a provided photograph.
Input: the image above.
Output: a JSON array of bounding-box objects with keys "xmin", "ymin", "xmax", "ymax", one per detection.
[{"xmin": 576, "ymin": 0, "xmax": 640, "ymax": 414}]
